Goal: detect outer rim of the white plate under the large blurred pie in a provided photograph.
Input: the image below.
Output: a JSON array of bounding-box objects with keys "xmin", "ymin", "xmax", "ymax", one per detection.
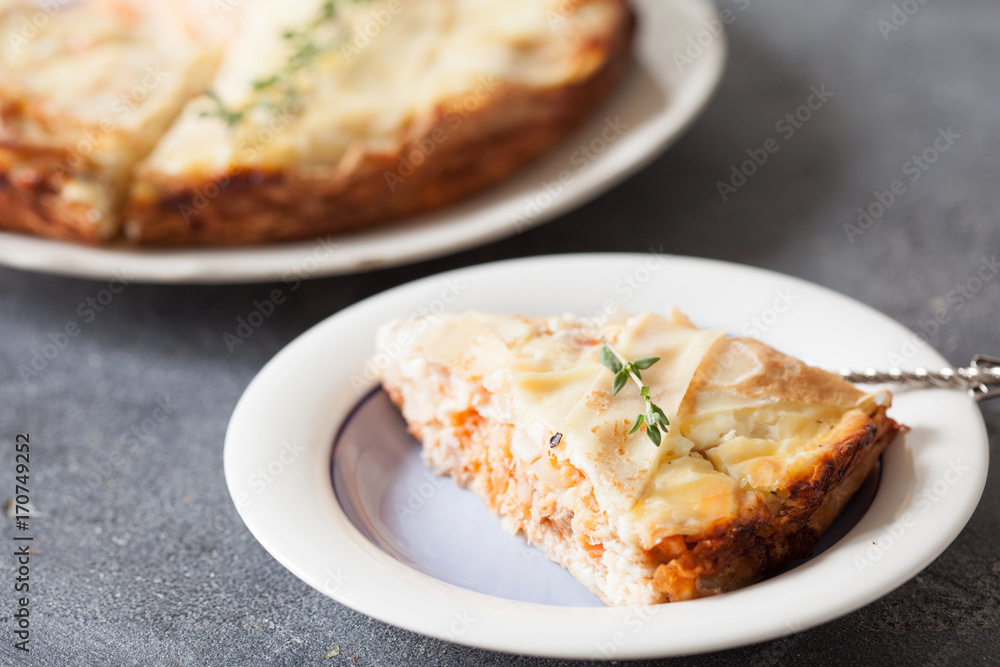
[{"xmin": 0, "ymin": 0, "xmax": 727, "ymax": 284}]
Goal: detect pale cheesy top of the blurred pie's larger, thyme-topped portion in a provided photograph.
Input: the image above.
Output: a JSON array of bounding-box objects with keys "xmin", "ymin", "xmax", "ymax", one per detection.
[{"xmin": 137, "ymin": 0, "xmax": 614, "ymax": 177}]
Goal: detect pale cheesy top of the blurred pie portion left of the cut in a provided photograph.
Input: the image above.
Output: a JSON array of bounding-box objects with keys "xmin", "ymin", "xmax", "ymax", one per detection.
[{"xmin": 0, "ymin": 0, "xmax": 214, "ymax": 128}]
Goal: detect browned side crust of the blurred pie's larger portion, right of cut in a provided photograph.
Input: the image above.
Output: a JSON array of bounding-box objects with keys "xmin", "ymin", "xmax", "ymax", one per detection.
[{"xmin": 125, "ymin": 0, "xmax": 635, "ymax": 245}]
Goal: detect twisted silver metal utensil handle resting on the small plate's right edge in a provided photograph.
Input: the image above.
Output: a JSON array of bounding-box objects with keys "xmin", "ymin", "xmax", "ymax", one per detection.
[{"xmin": 840, "ymin": 354, "xmax": 1000, "ymax": 401}]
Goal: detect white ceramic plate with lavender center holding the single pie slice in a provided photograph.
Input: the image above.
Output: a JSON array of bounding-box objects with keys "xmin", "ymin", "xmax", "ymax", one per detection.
[{"xmin": 225, "ymin": 254, "xmax": 988, "ymax": 658}]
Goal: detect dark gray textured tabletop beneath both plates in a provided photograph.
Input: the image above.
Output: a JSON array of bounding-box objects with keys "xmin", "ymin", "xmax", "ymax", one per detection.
[{"xmin": 0, "ymin": 0, "xmax": 1000, "ymax": 665}]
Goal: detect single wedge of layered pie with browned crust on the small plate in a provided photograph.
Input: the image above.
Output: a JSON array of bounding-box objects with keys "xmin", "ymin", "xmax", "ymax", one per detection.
[{"xmin": 379, "ymin": 314, "xmax": 900, "ymax": 604}]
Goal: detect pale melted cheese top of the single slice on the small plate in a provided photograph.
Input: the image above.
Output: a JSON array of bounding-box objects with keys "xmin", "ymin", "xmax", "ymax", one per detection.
[{"xmin": 384, "ymin": 313, "xmax": 874, "ymax": 549}]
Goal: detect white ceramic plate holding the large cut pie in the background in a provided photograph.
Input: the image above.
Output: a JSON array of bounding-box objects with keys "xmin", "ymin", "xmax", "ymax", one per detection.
[{"xmin": 0, "ymin": 0, "xmax": 725, "ymax": 283}]
